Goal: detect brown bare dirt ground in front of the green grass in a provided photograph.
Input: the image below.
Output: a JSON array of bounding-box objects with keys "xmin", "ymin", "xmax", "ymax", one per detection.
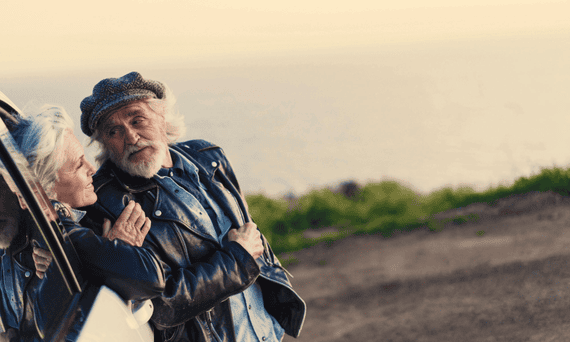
[{"xmin": 283, "ymin": 193, "xmax": 570, "ymax": 342}]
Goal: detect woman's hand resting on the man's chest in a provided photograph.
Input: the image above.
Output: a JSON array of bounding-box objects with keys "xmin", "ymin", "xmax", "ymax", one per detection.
[{"xmin": 103, "ymin": 201, "xmax": 150, "ymax": 247}]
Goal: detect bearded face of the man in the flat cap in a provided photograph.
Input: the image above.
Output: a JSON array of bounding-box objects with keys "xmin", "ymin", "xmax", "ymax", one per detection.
[{"xmin": 99, "ymin": 101, "xmax": 168, "ymax": 178}]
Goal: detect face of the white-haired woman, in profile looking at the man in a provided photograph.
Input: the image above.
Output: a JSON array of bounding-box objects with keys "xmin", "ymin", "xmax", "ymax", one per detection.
[{"xmin": 54, "ymin": 131, "xmax": 97, "ymax": 208}]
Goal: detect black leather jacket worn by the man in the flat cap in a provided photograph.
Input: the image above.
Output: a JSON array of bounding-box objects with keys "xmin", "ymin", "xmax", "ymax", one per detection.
[{"xmin": 82, "ymin": 140, "xmax": 306, "ymax": 341}]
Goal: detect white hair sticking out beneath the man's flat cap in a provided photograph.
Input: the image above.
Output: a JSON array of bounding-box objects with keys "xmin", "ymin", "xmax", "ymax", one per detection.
[{"xmin": 88, "ymin": 84, "xmax": 186, "ymax": 166}]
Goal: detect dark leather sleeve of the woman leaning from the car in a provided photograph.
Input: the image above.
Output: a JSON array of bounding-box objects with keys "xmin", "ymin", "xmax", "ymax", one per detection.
[{"xmin": 57, "ymin": 218, "xmax": 165, "ymax": 300}]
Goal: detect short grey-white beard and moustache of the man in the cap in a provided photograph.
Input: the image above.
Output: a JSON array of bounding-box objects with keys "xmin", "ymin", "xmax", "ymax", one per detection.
[{"xmin": 110, "ymin": 141, "xmax": 168, "ymax": 178}]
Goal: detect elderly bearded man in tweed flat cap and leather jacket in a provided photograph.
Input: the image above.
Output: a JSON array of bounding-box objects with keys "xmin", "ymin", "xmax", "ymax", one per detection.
[{"xmin": 81, "ymin": 72, "xmax": 306, "ymax": 341}]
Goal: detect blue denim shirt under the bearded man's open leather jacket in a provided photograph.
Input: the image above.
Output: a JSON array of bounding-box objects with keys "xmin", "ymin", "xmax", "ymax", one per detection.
[{"xmin": 154, "ymin": 149, "xmax": 285, "ymax": 342}]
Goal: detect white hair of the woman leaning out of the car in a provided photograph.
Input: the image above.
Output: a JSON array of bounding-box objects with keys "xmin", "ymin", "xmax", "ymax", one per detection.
[{"xmin": 12, "ymin": 105, "xmax": 74, "ymax": 199}]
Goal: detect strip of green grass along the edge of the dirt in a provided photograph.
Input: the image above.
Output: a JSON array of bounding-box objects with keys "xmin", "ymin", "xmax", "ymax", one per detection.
[{"xmin": 246, "ymin": 168, "xmax": 570, "ymax": 254}]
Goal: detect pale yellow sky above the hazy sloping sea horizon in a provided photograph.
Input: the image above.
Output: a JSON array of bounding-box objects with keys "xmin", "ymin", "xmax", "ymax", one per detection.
[{"xmin": 0, "ymin": 0, "xmax": 570, "ymax": 76}]
